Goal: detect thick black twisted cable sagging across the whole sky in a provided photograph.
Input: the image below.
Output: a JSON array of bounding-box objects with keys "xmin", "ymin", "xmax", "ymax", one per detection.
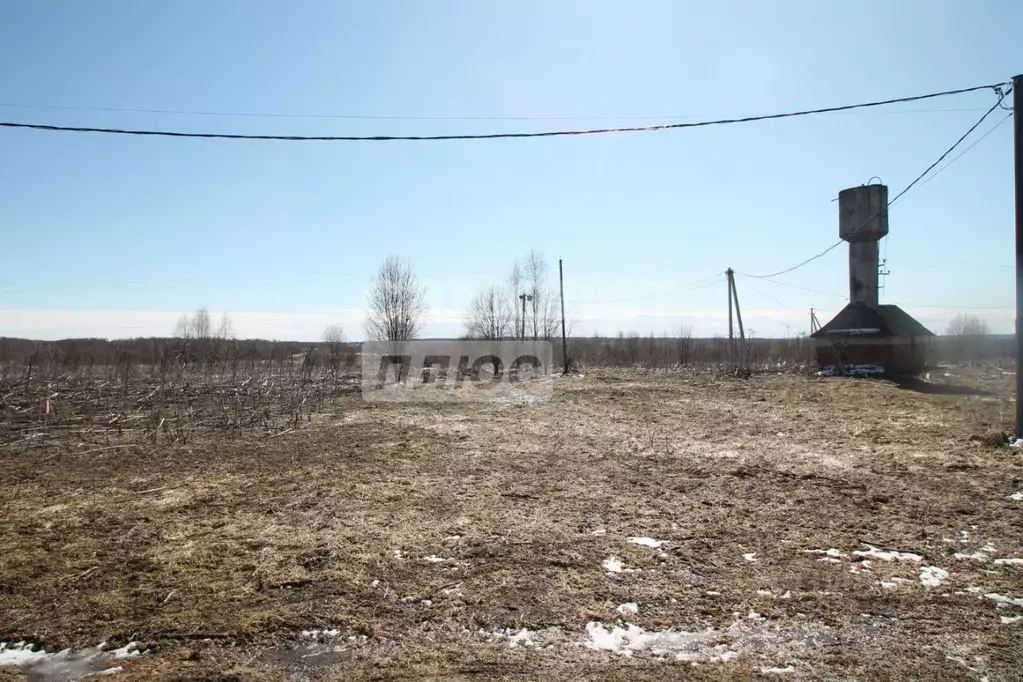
[{"xmin": 0, "ymin": 83, "xmax": 1005, "ymax": 142}]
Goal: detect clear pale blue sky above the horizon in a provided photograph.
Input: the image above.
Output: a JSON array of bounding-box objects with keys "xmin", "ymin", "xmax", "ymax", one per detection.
[{"xmin": 0, "ymin": 0, "xmax": 1023, "ymax": 339}]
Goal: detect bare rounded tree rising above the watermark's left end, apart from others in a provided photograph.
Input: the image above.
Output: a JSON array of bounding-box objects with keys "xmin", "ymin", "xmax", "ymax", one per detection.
[{"xmin": 366, "ymin": 256, "xmax": 427, "ymax": 342}]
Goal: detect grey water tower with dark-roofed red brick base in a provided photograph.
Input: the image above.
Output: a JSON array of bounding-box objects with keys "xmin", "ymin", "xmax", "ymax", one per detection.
[{"xmin": 810, "ymin": 184, "xmax": 934, "ymax": 376}]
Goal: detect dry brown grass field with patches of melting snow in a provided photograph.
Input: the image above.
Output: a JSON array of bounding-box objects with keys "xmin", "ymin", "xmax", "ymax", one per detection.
[{"xmin": 0, "ymin": 367, "xmax": 1023, "ymax": 682}]
